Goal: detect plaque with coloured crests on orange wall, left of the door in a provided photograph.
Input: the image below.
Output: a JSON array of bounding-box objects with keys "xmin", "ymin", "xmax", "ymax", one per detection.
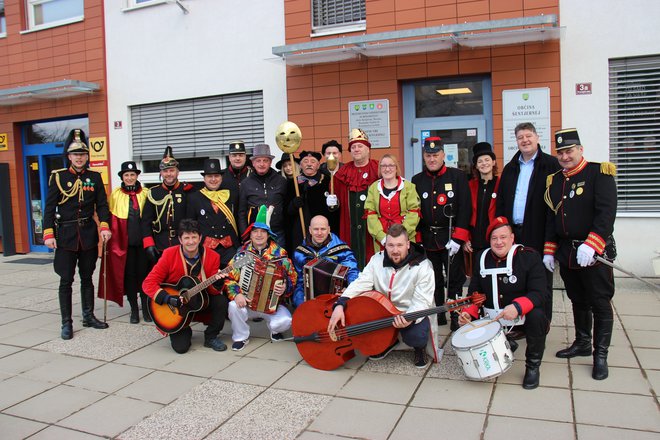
[{"xmin": 348, "ymin": 99, "xmax": 390, "ymax": 148}]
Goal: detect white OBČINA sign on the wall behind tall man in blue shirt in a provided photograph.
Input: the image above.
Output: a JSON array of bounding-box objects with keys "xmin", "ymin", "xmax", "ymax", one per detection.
[{"xmin": 502, "ymin": 87, "xmax": 552, "ymax": 164}]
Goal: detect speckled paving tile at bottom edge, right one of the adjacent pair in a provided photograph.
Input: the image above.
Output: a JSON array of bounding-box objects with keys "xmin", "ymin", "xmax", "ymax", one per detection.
[{"xmin": 207, "ymin": 389, "xmax": 331, "ymax": 440}]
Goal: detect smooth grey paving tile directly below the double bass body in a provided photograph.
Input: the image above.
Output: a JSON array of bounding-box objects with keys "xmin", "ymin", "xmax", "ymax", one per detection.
[{"xmin": 273, "ymin": 365, "xmax": 355, "ymax": 395}]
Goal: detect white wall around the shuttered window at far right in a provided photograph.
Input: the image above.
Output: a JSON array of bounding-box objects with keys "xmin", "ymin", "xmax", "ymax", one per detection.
[{"xmin": 559, "ymin": 0, "xmax": 660, "ymax": 276}]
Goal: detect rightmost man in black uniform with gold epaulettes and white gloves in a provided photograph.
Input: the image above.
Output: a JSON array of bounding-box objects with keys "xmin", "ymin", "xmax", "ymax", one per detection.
[{"xmin": 543, "ymin": 128, "xmax": 617, "ymax": 380}]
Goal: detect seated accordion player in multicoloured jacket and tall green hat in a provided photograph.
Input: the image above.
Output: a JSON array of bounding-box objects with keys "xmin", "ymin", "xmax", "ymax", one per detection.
[{"xmin": 225, "ymin": 205, "xmax": 298, "ymax": 351}]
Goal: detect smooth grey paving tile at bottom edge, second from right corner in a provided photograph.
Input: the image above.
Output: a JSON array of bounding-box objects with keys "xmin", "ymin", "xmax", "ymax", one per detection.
[{"xmin": 484, "ymin": 416, "xmax": 575, "ymax": 440}]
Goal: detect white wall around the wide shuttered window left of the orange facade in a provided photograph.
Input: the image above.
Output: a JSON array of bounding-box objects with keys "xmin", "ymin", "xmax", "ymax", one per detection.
[{"xmin": 104, "ymin": 0, "xmax": 287, "ymax": 186}]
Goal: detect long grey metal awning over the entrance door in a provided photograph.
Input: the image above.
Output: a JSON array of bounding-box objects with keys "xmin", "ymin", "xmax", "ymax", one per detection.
[{"xmin": 272, "ymin": 14, "xmax": 560, "ymax": 65}]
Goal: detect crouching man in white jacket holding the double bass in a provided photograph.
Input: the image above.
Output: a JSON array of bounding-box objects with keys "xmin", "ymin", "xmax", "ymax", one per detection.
[{"xmin": 328, "ymin": 224, "xmax": 435, "ymax": 368}]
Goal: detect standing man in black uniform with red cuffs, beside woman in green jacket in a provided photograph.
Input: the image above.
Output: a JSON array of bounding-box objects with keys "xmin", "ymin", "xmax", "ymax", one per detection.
[{"xmin": 412, "ymin": 137, "xmax": 472, "ymax": 331}]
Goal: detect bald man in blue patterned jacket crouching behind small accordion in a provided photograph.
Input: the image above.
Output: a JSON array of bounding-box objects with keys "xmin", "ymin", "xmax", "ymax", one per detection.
[{"xmin": 293, "ymin": 215, "xmax": 360, "ymax": 307}]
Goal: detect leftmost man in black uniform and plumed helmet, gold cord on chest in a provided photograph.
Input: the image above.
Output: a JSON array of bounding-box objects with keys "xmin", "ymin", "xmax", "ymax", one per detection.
[{"xmin": 44, "ymin": 129, "xmax": 112, "ymax": 339}]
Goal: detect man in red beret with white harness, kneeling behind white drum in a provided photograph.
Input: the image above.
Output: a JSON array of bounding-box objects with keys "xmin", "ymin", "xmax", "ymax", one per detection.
[{"xmin": 459, "ymin": 217, "xmax": 550, "ymax": 390}]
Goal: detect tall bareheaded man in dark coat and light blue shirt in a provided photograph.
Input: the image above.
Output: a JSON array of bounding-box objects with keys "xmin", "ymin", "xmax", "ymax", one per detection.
[{"xmin": 495, "ymin": 122, "xmax": 560, "ymax": 321}]
